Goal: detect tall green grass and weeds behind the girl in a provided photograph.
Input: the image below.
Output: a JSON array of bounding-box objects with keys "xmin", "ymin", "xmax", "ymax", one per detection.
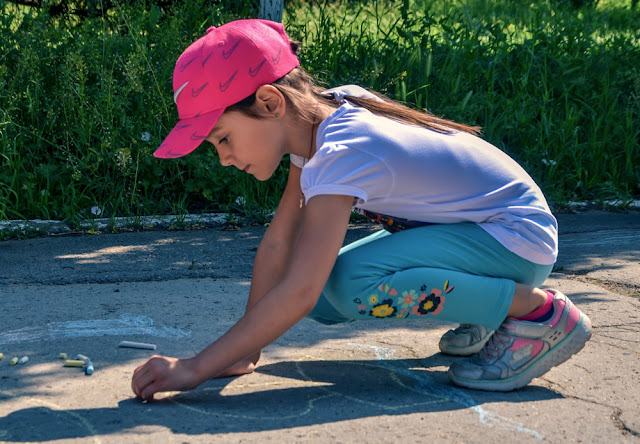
[{"xmin": 0, "ymin": 0, "xmax": 640, "ymax": 227}]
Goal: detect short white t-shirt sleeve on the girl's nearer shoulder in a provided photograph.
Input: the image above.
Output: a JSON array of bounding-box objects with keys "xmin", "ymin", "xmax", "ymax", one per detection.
[{"xmin": 300, "ymin": 145, "xmax": 393, "ymax": 204}]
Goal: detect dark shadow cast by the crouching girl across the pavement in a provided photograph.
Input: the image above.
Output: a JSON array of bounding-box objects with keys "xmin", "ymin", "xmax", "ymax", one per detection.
[{"xmin": 0, "ymin": 354, "xmax": 562, "ymax": 442}]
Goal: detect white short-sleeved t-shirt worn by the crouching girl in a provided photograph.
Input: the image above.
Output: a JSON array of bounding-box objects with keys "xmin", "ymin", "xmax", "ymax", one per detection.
[{"xmin": 291, "ymin": 86, "xmax": 558, "ymax": 265}]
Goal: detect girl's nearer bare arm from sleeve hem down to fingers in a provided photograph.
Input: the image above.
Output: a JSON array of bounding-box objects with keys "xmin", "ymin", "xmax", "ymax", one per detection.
[{"xmin": 132, "ymin": 195, "xmax": 353, "ymax": 399}]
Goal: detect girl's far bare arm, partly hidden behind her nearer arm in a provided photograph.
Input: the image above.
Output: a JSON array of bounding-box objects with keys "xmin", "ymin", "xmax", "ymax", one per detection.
[{"xmin": 217, "ymin": 163, "xmax": 305, "ymax": 377}]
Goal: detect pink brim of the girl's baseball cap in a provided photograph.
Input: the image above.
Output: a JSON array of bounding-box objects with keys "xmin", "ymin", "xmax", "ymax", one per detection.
[{"xmin": 153, "ymin": 109, "xmax": 224, "ymax": 159}]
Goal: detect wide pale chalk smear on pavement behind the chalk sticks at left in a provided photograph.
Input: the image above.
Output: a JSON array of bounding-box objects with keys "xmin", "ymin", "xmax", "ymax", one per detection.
[{"xmin": 0, "ymin": 313, "xmax": 191, "ymax": 345}]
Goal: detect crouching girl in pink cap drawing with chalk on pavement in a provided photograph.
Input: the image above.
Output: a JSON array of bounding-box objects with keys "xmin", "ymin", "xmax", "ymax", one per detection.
[{"xmin": 132, "ymin": 20, "xmax": 591, "ymax": 400}]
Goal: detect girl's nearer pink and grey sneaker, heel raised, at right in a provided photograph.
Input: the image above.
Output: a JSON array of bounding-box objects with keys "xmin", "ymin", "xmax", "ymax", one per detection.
[{"xmin": 448, "ymin": 290, "xmax": 591, "ymax": 392}]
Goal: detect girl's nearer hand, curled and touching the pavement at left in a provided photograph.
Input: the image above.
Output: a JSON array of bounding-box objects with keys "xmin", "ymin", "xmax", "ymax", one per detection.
[{"xmin": 131, "ymin": 355, "xmax": 202, "ymax": 401}]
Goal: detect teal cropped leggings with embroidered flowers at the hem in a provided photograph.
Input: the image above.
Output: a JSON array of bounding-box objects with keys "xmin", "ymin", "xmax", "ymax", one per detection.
[{"xmin": 307, "ymin": 223, "xmax": 553, "ymax": 330}]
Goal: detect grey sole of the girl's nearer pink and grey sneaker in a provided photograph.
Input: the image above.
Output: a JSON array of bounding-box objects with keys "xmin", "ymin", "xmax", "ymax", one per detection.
[{"xmin": 447, "ymin": 312, "xmax": 591, "ymax": 392}]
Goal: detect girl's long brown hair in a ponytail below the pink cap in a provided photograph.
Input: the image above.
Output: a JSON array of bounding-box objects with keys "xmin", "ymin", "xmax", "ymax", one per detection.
[{"xmin": 227, "ymin": 42, "xmax": 480, "ymax": 135}]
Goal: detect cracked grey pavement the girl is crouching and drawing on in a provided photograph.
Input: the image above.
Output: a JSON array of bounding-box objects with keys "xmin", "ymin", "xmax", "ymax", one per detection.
[{"xmin": 0, "ymin": 212, "xmax": 640, "ymax": 443}]
